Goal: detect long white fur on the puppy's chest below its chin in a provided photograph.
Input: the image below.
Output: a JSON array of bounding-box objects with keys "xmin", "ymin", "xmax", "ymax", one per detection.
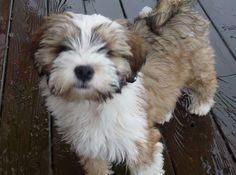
[{"xmin": 41, "ymin": 78, "xmax": 147, "ymax": 162}]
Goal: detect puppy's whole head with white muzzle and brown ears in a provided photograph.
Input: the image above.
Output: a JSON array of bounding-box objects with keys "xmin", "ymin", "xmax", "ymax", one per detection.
[{"xmin": 33, "ymin": 12, "xmax": 146, "ymax": 100}]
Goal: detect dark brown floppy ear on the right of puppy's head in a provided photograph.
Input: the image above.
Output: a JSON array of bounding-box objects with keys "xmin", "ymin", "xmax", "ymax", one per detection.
[{"xmin": 127, "ymin": 34, "xmax": 148, "ymax": 83}]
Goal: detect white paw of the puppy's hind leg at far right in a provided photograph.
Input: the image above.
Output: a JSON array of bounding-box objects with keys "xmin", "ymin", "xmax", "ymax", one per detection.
[{"xmin": 188, "ymin": 99, "xmax": 214, "ymax": 116}]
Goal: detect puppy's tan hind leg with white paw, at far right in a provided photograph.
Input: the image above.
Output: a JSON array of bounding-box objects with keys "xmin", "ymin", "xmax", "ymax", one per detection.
[{"xmin": 187, "ymin": 48, "xmax": 217, "ymax": 116}]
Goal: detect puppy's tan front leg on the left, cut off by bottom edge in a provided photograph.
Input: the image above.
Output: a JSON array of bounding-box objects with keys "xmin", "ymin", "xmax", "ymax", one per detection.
[{"xmin": 81, "ymin": 158, "xmax": 113, "ymax": 175}]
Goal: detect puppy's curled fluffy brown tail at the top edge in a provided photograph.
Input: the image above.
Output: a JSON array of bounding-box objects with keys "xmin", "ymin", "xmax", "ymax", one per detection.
[{"xmin": 146, "ymin": 0, "xmax": 192, "ymax": 33}]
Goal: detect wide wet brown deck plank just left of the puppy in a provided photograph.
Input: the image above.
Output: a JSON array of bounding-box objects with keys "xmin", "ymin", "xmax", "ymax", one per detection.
[{"xmin": 0, "ymin": 0, "xmax": 49, "ymax": 175}]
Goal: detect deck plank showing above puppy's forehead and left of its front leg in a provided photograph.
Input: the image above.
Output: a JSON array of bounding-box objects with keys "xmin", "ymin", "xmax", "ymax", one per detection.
[{"xmin": 48, "ymin": 0, "xmax": 85, "ymax": 175}]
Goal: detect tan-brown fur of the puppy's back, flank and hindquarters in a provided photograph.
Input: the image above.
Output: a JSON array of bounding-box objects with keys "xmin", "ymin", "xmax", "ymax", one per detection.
[{"xmin": 131, "ymin": 0, "xmax": 217, "ymax": 123}]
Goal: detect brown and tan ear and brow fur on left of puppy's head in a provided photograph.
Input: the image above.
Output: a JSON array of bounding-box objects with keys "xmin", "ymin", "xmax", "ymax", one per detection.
[{"xmin": 32, "ymin": 12, "xmax": 81, "ymax": 75}]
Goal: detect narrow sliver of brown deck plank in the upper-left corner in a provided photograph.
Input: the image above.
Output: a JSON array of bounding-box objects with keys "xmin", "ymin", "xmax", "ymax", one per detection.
[{"xmin": 0, "ymin": 0, "xmax": 13, "ymax": 105}]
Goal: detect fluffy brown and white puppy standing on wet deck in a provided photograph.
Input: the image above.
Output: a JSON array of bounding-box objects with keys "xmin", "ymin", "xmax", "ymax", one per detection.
[{"xmin": 34, "ymin": 0, "xmax": 217, "ymax": 175}]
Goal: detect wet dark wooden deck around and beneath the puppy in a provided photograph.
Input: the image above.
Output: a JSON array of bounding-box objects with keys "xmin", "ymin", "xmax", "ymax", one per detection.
[{"xmin": 0, "ymin": 0, "xmax": 236, "ymax": 175}]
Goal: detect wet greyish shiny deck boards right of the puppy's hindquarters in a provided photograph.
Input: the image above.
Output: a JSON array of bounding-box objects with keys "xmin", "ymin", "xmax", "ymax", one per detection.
[{"xmin": 197, "ymin": 0, "xmax": 236, "ymax": 158}]
